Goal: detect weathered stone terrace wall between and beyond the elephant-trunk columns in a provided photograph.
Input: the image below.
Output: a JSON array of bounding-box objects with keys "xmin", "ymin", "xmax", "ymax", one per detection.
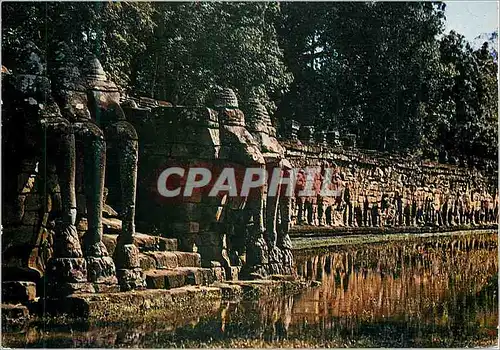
[{"xmin": 125, "ymin": 98, "xmax": 498, "ymax": 278}]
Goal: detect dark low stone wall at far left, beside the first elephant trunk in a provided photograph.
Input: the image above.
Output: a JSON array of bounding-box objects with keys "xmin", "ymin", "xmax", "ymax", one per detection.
[{"xmin": 2, "ymin": 159, "xmax": 56, "ymax": 280}]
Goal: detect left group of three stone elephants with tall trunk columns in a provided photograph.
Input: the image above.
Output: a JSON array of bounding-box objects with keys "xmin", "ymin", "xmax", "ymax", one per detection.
[{"xmin": 2, "ymin": 43, "xmax": 145, "ymax": 295}]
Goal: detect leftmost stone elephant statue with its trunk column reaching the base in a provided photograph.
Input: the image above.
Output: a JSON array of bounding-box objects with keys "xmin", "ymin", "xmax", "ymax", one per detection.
[{"xmin": 3, "ymin": 43, "xmax": 93, "ymax": 295}]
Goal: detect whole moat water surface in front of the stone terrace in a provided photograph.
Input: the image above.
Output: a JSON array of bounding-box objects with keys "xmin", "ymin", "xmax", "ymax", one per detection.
[{"xmin": 2, "ymin": 233, "xmax": 498, "ymax": 348}]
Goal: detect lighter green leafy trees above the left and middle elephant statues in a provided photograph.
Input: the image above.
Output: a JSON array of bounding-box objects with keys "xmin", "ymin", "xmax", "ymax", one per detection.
[{"xmin": 2, "ymin": 2, "xmax": 290, "ymax": 107}]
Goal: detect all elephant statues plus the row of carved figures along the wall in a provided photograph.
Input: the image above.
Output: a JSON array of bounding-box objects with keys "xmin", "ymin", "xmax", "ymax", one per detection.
[{"xmin": 2, "ymin": 44, "xmax": 498, "ymax": 294}]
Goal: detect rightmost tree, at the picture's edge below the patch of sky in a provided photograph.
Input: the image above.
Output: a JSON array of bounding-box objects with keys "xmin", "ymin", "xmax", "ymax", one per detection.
[{"xmin": 438, "ymin": 31, "xmax": 498, "ymax": 161}]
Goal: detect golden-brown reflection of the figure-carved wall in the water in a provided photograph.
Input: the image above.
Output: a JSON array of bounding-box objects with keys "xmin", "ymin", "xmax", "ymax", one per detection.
[{"xmin": 292, "ymin": 234, "xmax": 498, "ymax": 345}]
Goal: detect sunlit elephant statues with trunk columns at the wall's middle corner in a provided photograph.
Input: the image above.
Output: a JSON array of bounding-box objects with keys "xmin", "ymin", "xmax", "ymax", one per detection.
[{"xmin": 205, "ymin": 88, "xmax": 294, "ymax": 277}]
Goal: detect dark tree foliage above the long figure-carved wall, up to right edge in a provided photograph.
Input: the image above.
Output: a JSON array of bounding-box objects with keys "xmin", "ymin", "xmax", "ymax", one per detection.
[{"xmin": 277, "ymin": 2, "xmax": 497, "ymax": 165}]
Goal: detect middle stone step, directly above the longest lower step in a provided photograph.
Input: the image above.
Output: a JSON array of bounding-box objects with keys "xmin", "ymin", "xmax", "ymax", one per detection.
[{"xmin": 139, "ymin": 251, "xmax": 201, "ymax": 271}]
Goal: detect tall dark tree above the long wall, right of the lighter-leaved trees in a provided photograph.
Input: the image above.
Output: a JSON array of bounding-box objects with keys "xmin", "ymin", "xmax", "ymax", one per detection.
[{"xmin": 280, "ymin": 2, "xmax": 444, "ymax": 150}]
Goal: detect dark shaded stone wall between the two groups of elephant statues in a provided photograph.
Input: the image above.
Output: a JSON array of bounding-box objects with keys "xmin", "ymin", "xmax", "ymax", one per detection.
[{"xmin": 125, "ymin": 106, "xmax": 222, "ymax": 266}]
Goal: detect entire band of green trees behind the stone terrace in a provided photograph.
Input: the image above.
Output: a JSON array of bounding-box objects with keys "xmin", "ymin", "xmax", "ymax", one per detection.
[{"xmin": 2, "ymin": 2, "xmax": 498, "ymax": 166}]
